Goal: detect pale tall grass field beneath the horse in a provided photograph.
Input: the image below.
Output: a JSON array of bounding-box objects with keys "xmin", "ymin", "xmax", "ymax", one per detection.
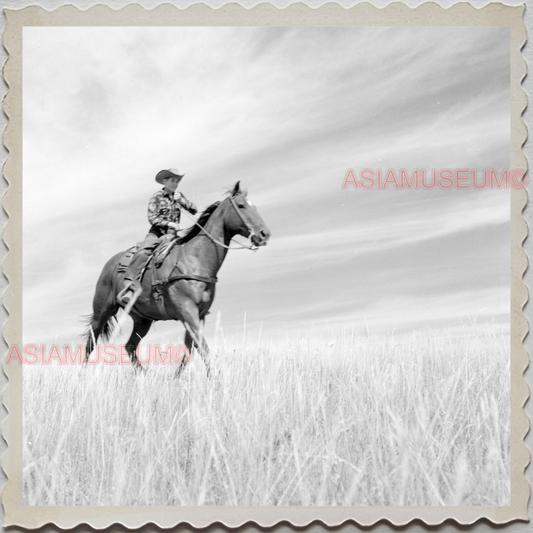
[{"xmin": 23, "ymin": 327, "xmax": 510, "ymax": 505}]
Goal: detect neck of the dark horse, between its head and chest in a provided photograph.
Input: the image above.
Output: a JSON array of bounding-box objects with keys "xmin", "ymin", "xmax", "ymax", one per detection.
[{"xmin": 181, "ymin": 202, "xmax": 235, "ymax": 276}]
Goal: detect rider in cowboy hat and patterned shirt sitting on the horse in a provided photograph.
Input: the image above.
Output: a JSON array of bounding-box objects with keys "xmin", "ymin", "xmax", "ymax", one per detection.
[{"xmin": 119, "ymin": 168, "xmax": 198, "ymax": 304}]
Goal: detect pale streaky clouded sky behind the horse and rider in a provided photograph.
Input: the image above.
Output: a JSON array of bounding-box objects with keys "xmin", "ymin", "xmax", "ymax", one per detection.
[{"xmin": 23, "ymin": 27, "xmax": 510, "ymax": 344}]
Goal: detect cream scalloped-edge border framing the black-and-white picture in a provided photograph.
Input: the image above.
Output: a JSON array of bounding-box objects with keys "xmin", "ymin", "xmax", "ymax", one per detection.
[{"xmin": 2, "ymin": 2, "xmax": 530, "ymax": 529}]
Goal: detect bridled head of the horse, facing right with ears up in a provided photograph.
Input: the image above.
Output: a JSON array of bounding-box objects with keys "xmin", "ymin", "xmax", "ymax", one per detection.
[{"xmin": 225, "ymin": 181, "xmax": 270, "ymax": 246}]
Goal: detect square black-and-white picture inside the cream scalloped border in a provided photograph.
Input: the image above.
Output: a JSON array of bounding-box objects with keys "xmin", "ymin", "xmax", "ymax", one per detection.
[{"xmin": 6, "ymin": 4, "xmax": 529, "ymax": 524}]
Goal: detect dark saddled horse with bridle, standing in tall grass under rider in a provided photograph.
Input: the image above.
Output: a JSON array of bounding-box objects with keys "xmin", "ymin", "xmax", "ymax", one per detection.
[{"xmin": 85, "ymin": 182, "xmax": 270, "ymax": 376}]
